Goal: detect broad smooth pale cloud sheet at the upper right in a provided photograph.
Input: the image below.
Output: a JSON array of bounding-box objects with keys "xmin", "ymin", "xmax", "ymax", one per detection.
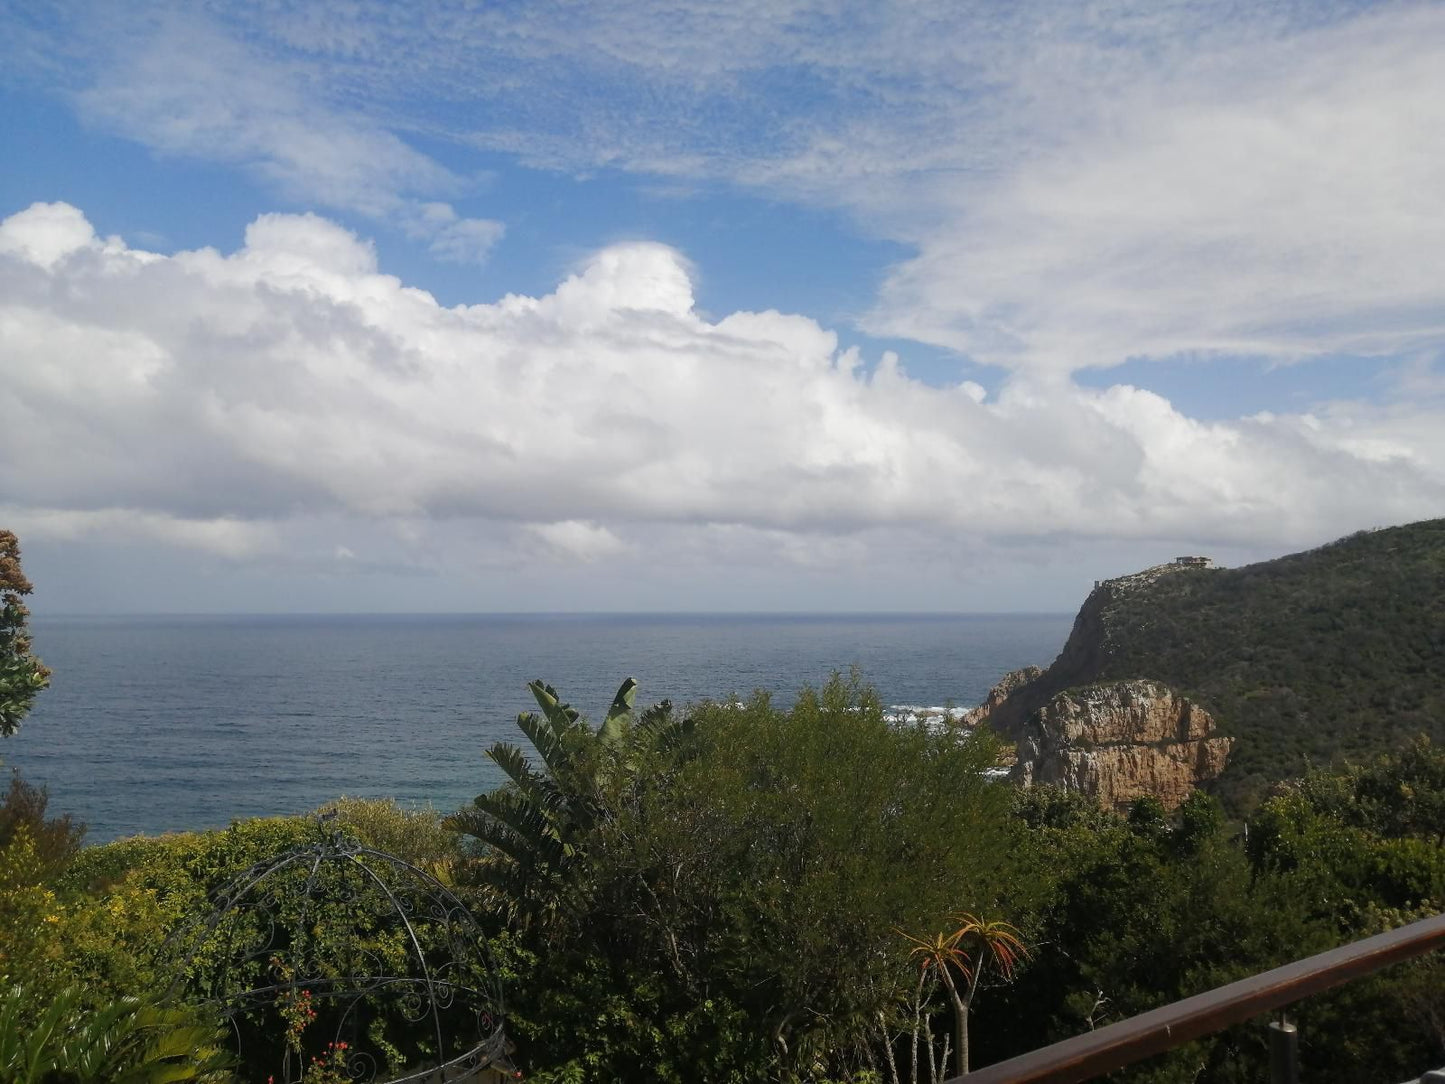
[{"xmin": 870, "ymin": 9, "xmax": 1445, "ymax": 370}]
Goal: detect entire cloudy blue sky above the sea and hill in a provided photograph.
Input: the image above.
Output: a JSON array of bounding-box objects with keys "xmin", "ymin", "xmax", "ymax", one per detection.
[{"xmin": 0, "ymin": 0, "xmax": 1445, "ymax": 613}]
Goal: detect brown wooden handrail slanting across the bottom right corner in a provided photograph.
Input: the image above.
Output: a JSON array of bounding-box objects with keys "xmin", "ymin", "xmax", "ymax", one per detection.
[{"xmin": 945, "ymin": 915, "xmax": 1445, "ymax": 1084}]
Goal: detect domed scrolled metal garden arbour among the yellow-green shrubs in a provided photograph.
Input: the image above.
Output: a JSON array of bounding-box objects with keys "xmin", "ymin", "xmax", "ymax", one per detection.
[{"xmin": 171, "ymin": 818, "xmax": 512, "ymax": 1084}]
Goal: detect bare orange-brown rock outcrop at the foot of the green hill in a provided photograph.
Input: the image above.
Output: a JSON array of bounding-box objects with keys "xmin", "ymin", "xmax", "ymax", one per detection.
[{"xmin": 1010, "ymin": 679, "xmax": 1231, "ymax": 809}]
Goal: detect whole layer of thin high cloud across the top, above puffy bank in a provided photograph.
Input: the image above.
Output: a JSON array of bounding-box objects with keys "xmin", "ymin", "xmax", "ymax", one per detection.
[{"xmin": 28, "ymin": 3, "xmax": 1445, "ymax": 370}]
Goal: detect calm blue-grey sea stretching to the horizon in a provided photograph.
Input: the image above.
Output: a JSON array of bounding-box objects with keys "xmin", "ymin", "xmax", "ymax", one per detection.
[{"xmin": 0, "ymin": 614, "xmax": 1072, "ymax": 843}]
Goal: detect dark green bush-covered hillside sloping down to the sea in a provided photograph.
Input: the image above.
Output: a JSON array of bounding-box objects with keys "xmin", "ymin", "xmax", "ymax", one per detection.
[{"xmin": 990, "ymin": 519, "xmax": 1445, "ymax": 811}]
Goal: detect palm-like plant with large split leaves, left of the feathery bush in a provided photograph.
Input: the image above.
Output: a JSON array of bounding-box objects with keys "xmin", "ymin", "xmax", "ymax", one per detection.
[{"xmin": 444, "ymin": 678, "xmax": 688, "ymax": 925}]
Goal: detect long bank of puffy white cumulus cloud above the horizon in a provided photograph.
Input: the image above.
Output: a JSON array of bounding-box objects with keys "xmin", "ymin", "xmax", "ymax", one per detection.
[{"xmin": 0, "ymin": 204, "xmax": 1445, "ymax": 595}]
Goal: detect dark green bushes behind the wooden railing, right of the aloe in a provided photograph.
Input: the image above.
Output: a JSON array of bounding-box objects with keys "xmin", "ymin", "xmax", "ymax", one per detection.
[{"xmin": 977, "ymin": 744, "xmax": 1445, "ymax": 1084}]
